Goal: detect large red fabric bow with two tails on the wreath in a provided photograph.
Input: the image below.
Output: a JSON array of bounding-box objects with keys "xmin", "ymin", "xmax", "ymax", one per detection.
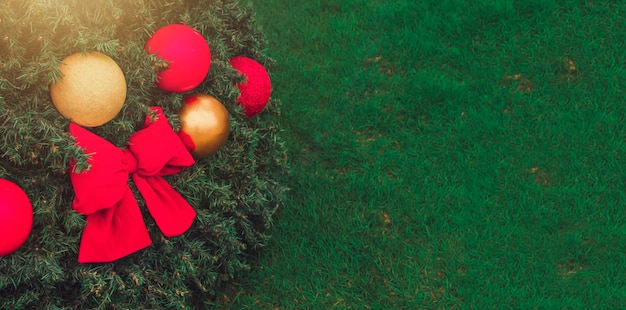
[{"xmin": 70, "ymin": 107, "xmax": 196, "ymax": 263}]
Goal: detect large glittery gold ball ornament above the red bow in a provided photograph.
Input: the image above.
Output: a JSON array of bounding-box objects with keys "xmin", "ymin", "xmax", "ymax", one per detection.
[{"xmin": 50, "ymin": 52, "xmax": 126, "ymax": 127}]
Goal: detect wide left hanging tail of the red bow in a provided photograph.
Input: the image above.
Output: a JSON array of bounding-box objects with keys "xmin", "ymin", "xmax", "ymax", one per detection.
[{"xmin": 78, "ymin": 189, "xmax": 152, "ymax": 263}]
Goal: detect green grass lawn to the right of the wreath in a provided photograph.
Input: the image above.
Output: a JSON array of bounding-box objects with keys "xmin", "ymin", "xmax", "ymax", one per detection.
[{"xmin": 220, "ymin": 0, "xmax": 626, "ymax": 309}]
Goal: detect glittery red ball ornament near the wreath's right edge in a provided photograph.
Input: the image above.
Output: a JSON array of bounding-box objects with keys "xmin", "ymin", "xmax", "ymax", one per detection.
[{"xmin": 230, "ymin": 56, "xmax": 272, "ymax": 117}]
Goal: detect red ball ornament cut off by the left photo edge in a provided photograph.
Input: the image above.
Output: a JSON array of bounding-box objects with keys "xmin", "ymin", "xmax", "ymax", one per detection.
[{"xmin": 0, "ymin": 179, "xmax": 33, "ymax": 256}]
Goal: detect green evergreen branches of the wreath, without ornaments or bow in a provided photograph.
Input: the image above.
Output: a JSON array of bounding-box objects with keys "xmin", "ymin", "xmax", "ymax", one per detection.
[{"xmin": 0, "ymin": 0, "xmax": 288, "ymax": 309}]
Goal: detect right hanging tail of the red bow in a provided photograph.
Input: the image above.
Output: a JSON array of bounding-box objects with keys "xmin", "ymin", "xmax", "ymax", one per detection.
[{"xmin": 133, "ymin": 174, "xmax": 196, "ymax": 237}]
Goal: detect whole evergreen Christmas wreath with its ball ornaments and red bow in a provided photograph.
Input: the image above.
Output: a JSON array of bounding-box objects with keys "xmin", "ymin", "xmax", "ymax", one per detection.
[{"xmin": 0, "ymin": 0, "xmax": 287, "ymax": 309}]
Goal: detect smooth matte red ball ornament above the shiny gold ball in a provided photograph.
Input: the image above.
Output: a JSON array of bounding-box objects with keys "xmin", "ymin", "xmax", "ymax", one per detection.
[{"xmin": 145, "ymin": 24, "xmax": 211, "ymax": 92}]
